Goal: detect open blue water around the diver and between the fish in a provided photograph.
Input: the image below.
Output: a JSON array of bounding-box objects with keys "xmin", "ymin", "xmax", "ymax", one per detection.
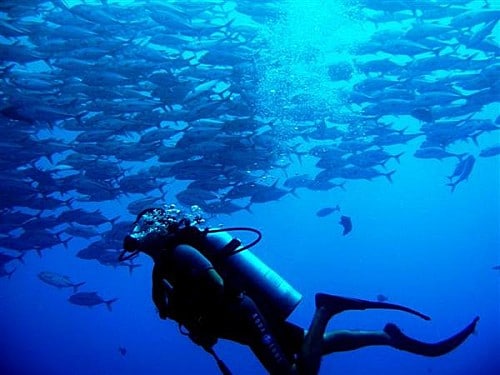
[{"xmin": 0, "ymin": 1, "xmax": 500, "ymax": 375}]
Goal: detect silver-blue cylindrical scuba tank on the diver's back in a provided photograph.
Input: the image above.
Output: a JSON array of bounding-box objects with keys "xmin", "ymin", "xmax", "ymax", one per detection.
[{"xmin": 203, "ymin": 232, "xmax": 302, "ymax": 319}]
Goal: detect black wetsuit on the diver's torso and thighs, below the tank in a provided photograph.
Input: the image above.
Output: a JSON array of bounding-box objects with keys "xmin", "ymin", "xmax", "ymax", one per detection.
[{"xmin": 153, "ymin": 244, "xmax": 304, "ymax": 374}]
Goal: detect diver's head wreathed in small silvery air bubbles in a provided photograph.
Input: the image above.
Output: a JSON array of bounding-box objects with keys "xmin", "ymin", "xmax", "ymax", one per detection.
[{"xmin": 122, "ymin": 205, "xmax": 203, "ymax": 258}]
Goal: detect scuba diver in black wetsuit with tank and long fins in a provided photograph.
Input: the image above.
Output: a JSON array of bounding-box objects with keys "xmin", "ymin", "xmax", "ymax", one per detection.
[{"xmin": 120, "ymin": 205, "xmax": 479, "ymax": 375}]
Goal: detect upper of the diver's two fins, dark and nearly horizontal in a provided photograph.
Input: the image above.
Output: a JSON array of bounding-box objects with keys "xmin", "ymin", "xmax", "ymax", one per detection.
[{"xmin": 316, "ymin": 293, "xmax": 431, "ymax": 320}]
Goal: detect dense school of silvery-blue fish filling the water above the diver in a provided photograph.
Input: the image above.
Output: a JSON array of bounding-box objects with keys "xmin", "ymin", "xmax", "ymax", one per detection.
[{"xmin": 0, "ymin": 0, "xmax": 500, "ymax": 302}]
